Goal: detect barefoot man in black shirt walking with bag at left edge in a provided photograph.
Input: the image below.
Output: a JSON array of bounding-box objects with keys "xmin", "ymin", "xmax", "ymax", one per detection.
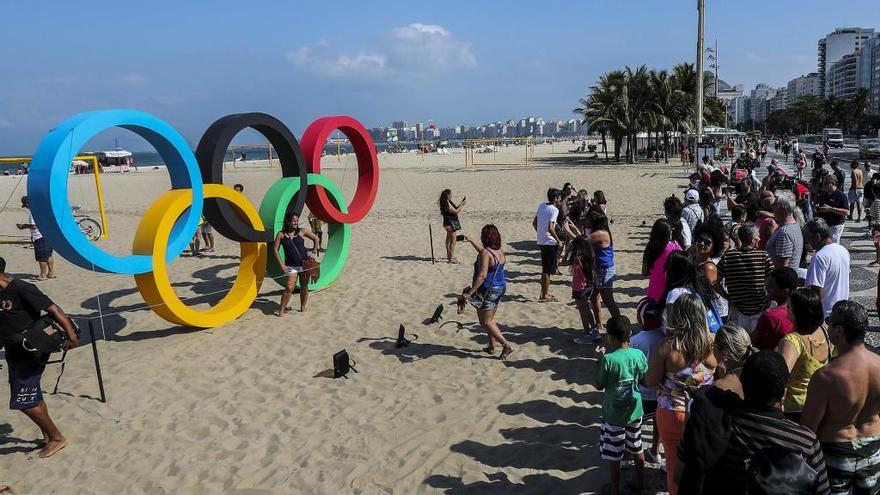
[{"xmin": 0, "ymin": 258, "xmax": 79, "ymax": 457}]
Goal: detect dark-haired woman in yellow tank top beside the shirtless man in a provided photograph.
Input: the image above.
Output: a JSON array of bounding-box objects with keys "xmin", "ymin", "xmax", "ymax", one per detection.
[{"xmin": 776, "ymin": 287, "xmax": 832, "ymax": 423}]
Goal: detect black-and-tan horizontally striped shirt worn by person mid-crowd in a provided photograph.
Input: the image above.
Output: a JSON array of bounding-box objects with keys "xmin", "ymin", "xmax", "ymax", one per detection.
[{"xmin": 718, "ymin": 249, "xmax": 773, "ymax": 315}]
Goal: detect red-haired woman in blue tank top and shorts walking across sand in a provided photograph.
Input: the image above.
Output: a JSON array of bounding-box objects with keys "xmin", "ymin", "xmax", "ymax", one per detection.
[{"xmin": 458, "ymin": 224, "xmax": 513, "ymax": 360}]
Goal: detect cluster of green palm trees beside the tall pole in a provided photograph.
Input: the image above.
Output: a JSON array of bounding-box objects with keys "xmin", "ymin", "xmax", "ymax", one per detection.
[{"xmin": 573, "ymin": 63, "xmax": 725, "ymax": 163}]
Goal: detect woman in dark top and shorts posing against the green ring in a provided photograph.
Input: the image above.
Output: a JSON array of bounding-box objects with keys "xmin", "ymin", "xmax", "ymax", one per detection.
[{"xmin": 273, "ymin": 213, "xmax": 318, "ymax": 317}]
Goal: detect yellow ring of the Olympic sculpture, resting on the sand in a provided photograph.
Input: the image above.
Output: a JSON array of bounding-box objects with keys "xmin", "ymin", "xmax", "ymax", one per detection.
[{"xmin": 133, "ymin": 184, "xmax": 267, "ymax": 328}]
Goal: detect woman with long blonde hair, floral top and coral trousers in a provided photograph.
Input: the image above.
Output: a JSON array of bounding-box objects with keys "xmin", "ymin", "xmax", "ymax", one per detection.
[{"xmin": 644, "ymin": 294, "xmax": 716, "ymax": 495}]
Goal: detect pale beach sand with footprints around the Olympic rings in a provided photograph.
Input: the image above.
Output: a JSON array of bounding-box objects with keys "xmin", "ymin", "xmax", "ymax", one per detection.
[{"xmin": 0, "ymin": 144, "xmax": 683, "ymax": 494}]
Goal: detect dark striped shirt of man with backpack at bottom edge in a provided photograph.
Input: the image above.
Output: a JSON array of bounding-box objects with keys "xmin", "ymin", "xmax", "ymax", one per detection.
[{"xmin": 678, "ymin": 389, "xmax": 830, "ymax": 495}]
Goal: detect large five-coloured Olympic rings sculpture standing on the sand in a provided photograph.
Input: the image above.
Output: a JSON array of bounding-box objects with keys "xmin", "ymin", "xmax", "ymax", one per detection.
[{"xmin": 28, "ymin": 110, "xmax": 379, "ymax": 328}]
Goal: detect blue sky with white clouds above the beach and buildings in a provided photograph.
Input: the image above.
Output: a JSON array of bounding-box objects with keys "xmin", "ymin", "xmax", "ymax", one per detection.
[{"xmin": 0, "ymin": 0, "xmax": 880, "ymax": 155}]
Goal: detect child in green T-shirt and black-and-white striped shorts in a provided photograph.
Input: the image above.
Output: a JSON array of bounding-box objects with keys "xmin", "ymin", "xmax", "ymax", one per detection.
[{"xmin": 593, "ymin": 316, "xmax": 648, "ymax": 495}]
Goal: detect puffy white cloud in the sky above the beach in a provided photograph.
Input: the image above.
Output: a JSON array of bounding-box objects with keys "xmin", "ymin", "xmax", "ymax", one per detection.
[{"xmin": 287, "ymin": 22, "xmax": 477, "ymax": 78}]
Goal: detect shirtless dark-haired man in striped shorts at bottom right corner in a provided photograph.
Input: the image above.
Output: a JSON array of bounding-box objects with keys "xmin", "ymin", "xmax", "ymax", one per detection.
[{"xmin": 801, "ymin": 301, "xmax": 880, "ymax": 495}]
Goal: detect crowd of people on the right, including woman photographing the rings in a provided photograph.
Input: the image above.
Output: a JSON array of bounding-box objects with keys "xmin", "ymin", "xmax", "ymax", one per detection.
[{"xmin": 441, "ymin": 138, "xmax": 880, "ymax": 495}]
